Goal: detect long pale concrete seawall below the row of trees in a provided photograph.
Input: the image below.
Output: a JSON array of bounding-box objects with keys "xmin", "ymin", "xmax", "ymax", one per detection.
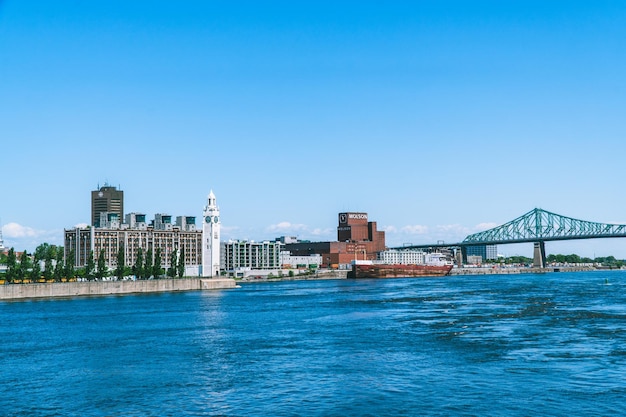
[{"xmin": 0, "ymin": 278, "xmax": 237, "ymax": 300}]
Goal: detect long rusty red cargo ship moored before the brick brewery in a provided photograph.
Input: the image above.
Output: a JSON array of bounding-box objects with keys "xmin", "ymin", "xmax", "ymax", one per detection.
[{"xmin": 348, "ymin": 261, "xmax": 453, "ymax": 278}]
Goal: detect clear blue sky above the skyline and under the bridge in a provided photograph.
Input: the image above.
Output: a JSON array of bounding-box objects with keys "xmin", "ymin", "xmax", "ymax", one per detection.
[{"xmin": 0, "ymin": 0, "xmax": 626, "ymax": 258}]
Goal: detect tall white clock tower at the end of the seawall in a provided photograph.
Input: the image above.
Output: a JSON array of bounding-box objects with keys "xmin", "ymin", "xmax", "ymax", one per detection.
[{"xmin": 202, "ymin": 190, "xmax": 221, "ymax": 277}]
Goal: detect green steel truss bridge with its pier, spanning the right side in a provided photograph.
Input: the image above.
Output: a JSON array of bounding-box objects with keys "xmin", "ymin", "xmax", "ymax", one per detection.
[{"xmin": 395, "ymin": 208, "xmax": 626, "ymax": 267}]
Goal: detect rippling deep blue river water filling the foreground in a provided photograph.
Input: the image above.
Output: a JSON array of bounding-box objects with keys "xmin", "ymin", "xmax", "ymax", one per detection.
[{"xmin": 0, "ymin": 271, "xmax": 626, "ymax": 416}]
